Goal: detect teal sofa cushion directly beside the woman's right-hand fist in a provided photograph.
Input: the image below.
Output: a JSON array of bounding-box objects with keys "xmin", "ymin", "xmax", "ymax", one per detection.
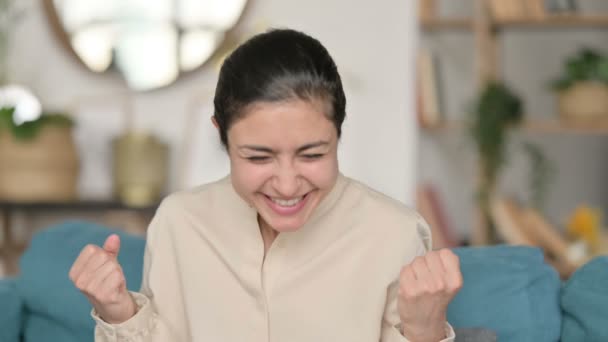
[{"xmin": 448, "ymin": 245, "xmax": 561, "ymax": 342}]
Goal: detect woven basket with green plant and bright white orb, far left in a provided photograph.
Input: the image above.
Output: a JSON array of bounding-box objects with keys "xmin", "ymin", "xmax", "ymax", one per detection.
[{"xmin": 0, "ymin": 86, "xmax": 79, "ymax": 202}]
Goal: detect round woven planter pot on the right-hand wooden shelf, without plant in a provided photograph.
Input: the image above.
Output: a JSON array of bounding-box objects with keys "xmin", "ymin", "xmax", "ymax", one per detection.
[{"xmin": 558, "ymin": 81, "xmax": 608, "ymax": 124}]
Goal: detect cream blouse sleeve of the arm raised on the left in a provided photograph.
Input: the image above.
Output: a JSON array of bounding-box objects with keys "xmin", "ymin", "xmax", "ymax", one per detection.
[{"xmin": 91, "ymin": 203, "xmax": 189, "ymax": 342}]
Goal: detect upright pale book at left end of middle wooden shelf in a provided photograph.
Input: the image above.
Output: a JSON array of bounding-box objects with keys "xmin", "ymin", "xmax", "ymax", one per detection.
[{"xmin": 416, "ymin": 48, "xmax": 442, "ymax": 128}]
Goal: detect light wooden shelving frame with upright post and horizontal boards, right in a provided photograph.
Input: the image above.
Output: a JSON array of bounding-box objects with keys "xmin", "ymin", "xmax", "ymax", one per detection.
[{"xmin": 420, "ymin": 0, "xmax": 608, "ymax": 245}]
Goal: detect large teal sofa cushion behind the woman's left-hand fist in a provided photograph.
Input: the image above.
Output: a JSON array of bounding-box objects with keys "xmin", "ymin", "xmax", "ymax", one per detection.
[{"xmin": 17, "ymin": 221, "xmax": 145, "ymax": 341}]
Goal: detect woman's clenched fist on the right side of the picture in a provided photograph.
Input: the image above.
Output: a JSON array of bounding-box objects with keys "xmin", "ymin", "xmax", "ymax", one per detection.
[{"xmin": 397, "ymin": 249, "xmax": 462, "ymax": 342}]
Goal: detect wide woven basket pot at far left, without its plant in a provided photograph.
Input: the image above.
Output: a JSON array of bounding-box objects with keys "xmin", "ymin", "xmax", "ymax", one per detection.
[{"xmin": 0, "ymin": 125, "xmax": 79, "ymax": 202}]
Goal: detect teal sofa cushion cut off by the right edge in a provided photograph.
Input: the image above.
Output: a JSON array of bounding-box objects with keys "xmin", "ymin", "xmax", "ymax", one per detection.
[{"xmin": 561, "ymin": 256, "xmax": 608, "ymax": 342}]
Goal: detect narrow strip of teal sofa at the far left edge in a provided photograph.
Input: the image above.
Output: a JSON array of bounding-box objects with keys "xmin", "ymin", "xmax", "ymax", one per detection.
[{"xmin": 0, "ymin": 278, "xmax": 23, "ymax": 342}]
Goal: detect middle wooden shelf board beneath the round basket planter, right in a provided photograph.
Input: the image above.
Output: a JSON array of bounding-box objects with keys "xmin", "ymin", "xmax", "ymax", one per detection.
[{"xmin": 422, "ymin": 119, "xmax": 608, "ymax": 135}]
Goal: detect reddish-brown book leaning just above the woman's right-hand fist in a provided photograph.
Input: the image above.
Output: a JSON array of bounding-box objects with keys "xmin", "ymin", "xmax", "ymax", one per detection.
[{"xmin": 416, "ymin": 184, "xmax": 460, "ymax": 249}]
